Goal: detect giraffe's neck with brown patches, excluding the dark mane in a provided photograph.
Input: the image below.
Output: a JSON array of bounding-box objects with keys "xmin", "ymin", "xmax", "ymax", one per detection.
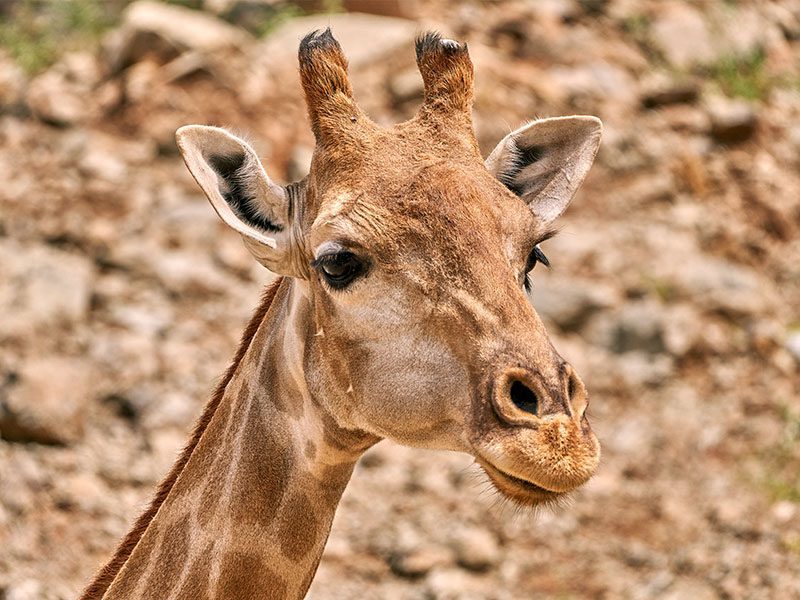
[{"xmin": 103, "ymin": 280, "xmax": 375, "ymax": 599}]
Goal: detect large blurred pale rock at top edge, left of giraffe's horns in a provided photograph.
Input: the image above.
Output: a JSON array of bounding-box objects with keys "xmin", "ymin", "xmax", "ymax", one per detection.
[{"xmin": 104, "ymin": 0, "xmax": 253, "ymax": 72}]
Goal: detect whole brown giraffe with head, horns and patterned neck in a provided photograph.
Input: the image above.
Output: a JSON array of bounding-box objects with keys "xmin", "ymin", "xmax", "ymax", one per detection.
[{"xmin": 82, "ymin": 29, "xmax": 601, "ymax": 600}]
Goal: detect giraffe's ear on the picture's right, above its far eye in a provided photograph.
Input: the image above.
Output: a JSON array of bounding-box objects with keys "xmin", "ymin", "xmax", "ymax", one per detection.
[{"xmin": 485, "ymin": 116, "xmax": 603, "ymax": 223}]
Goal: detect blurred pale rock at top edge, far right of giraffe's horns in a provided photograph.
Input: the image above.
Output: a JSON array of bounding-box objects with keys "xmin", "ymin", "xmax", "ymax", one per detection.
[{"xmin": 650, "ymin": 1, "xmax": 716, "ymax": 69}]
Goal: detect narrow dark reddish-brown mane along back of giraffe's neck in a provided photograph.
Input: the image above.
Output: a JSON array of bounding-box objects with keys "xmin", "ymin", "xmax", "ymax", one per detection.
[{"xmin": 80, "ymin": 277, "xmax": 283, "ymax": 600}]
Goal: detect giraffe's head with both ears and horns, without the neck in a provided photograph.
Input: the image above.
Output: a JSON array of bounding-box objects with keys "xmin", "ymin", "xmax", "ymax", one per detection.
[{"xmin": 177, "ymin": 31, "xmax": 601, "ymax": 505}]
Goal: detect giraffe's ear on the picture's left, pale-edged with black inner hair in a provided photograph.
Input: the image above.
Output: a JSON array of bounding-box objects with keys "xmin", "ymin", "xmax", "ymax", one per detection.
[{"xmin": 175, "ymin": 125, "xmax": 304, "ymax": 277}]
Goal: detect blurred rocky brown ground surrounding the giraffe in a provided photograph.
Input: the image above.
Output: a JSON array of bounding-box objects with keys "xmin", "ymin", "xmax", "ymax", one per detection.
[{"xmin": 0, "ymin": 0, "xmax": 800, "ymax": 600}]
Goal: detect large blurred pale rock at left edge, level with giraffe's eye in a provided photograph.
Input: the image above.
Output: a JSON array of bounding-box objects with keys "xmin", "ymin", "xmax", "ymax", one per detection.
[{"xmin": 0, "ymin": 240, "xmax": 94, "ymax": 339}]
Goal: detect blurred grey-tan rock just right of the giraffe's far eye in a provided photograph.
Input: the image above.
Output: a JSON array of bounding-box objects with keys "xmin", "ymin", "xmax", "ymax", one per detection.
[{"xmin": 529, "ymin": 277, "xmax": 619, "ymax": 331}]
